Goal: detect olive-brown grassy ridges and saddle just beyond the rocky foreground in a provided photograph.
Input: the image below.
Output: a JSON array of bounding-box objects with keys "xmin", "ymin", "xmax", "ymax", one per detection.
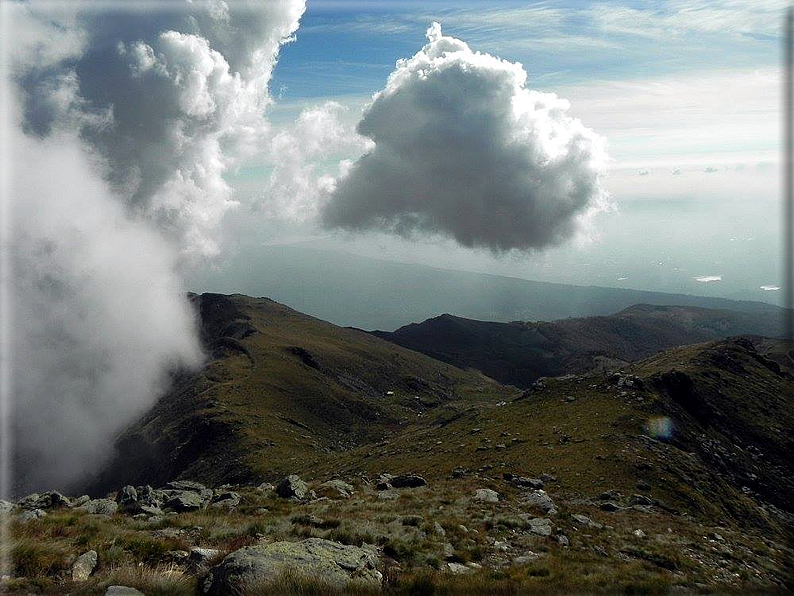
[{"xmin": 94, "ymin": 295, "xmax": 794, "ymax": 526}]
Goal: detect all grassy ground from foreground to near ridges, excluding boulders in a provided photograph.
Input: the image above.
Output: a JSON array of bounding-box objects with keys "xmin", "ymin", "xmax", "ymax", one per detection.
[{"xmin": 9, "ymin": 294, "xmax": 794, "ymax": 595}]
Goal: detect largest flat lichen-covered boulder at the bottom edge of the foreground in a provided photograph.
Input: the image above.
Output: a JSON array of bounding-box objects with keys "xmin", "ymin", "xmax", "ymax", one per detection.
[{"xmin": 202, "ymin": 538, "xmax": 383, "ymax": 596}]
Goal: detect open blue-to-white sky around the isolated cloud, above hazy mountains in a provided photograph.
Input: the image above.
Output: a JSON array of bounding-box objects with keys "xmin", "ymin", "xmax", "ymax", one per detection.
[{"xmin": 209, "ymin": 0, "xmax": 784, "ymax": 302}]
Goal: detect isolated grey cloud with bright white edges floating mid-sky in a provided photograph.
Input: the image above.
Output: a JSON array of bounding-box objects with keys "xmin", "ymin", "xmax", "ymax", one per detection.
[{"xmin": 322, "ymin": 23, "xmax": 607, "ymax": 252}]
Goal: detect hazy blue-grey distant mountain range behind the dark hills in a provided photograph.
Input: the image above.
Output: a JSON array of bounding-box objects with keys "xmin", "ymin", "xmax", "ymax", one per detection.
[{"xmin": 184, "ymin": 246, "xmax": 782, "ymax": 331}]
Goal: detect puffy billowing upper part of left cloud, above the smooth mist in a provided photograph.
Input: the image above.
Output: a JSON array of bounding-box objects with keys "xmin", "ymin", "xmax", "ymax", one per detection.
[{"xmin": 22, "ymin": 0, "xmax": 305, "ymax": 255}]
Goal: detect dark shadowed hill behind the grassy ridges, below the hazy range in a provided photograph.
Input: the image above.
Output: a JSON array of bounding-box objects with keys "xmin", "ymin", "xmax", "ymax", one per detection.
[{"xmin": 373, "ymin": 304, "xmax": 781, "ymax": 388}]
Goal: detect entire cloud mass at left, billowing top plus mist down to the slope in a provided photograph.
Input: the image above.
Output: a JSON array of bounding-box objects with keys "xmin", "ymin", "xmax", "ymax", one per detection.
[{"xmin": 6, "ymin": 0, "xmax": 304, "ymax": 492}]
